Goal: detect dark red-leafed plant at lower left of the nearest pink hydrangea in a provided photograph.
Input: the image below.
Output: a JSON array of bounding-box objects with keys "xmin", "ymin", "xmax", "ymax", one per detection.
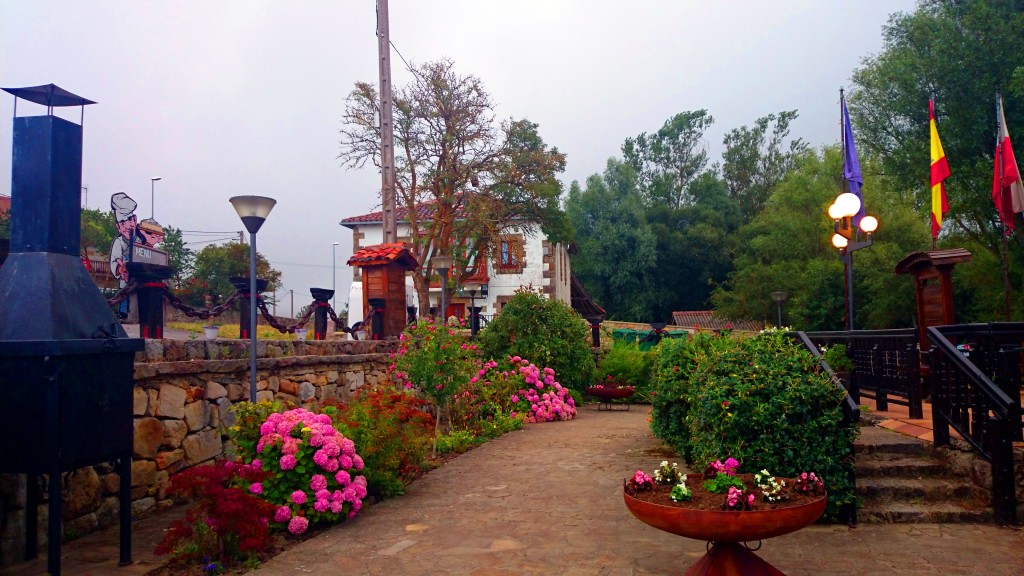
[{"xmin": 156, "ymin": 462, "xmax": 274, "ymax": 563}]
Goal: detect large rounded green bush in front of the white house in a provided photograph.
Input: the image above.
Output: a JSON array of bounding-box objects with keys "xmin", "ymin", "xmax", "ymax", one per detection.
[{"xmin": 476, "ymin": 289, "xmax": 594, "ymax": 390}]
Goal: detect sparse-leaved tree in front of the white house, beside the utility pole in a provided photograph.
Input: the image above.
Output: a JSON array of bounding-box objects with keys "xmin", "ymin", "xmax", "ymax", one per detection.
[{"xmin": 338, "ymin": 59, "xmax": 567, "ymax": 310}]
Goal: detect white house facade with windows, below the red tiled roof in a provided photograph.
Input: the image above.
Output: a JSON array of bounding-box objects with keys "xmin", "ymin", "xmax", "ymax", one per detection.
[{"xmin": 340, "ymin": 208, "xmax": 571, "ymax": 325}]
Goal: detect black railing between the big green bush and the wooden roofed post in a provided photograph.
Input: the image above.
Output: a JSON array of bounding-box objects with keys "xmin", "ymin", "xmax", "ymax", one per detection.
[{"xmin": 807, "ymin": 328, "xmax": 925, "ymax": 418}]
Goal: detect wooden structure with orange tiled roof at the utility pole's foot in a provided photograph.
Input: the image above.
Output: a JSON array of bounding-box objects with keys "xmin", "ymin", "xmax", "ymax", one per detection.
[{"xmin": 348, "ymin": 242, "xmax": 420, "ymax": 339}]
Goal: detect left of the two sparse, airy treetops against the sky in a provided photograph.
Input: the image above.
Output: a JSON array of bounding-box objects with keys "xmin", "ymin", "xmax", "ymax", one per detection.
[{"xmin": 623, "ymin": 110, "xmax": 715, "ymax": 208}]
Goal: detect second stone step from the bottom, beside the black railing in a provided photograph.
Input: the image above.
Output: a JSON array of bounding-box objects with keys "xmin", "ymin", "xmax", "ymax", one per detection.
[{"xmin": 857, "ymin": 477, "xmax": 987, "ymax": 502}]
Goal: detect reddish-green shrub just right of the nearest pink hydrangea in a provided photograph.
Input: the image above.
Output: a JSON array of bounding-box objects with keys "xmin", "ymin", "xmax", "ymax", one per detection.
[{"xmin": 335, "ymin": 386, "xmax": 434, "ymax": 498}]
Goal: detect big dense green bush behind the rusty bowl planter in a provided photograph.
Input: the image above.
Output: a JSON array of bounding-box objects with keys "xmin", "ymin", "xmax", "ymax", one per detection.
[{"xmin": 651, "ymin": 332, "xmax": 855, "ymax": 517}]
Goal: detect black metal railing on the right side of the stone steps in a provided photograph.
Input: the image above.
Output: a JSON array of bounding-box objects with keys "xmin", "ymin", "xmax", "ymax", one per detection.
[{"xmin": 928, "ymin": 325, "xmax": 1021, "ymax": 524}]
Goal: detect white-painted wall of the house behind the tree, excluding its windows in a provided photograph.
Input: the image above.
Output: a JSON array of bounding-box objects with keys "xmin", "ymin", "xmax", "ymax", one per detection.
[{"xmin": 346, "ymin": 219, "xmax": 571, "ymax": 325}]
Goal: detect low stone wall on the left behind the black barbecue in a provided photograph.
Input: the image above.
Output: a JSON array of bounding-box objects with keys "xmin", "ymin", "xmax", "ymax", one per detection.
[{"xmin": 0, "ymin": 339, "xmax": 394, "ymax": 565}]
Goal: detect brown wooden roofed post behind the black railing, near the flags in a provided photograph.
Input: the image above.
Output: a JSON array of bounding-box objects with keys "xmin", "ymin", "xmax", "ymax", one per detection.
[{"xmin": 896, "ymin": 248, "xmax": 974, "ymax": 352}]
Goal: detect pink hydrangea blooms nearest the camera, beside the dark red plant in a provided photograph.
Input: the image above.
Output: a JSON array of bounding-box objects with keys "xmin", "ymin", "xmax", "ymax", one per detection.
[{"xmin": 249, "ymin": 408, "xmax": 367, "ymax": 534}]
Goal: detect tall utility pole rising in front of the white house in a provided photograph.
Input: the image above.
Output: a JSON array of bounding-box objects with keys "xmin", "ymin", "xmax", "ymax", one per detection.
[{"xmin": 377, "ymin": 0, "xmax": 398, "ymax": 243}]
